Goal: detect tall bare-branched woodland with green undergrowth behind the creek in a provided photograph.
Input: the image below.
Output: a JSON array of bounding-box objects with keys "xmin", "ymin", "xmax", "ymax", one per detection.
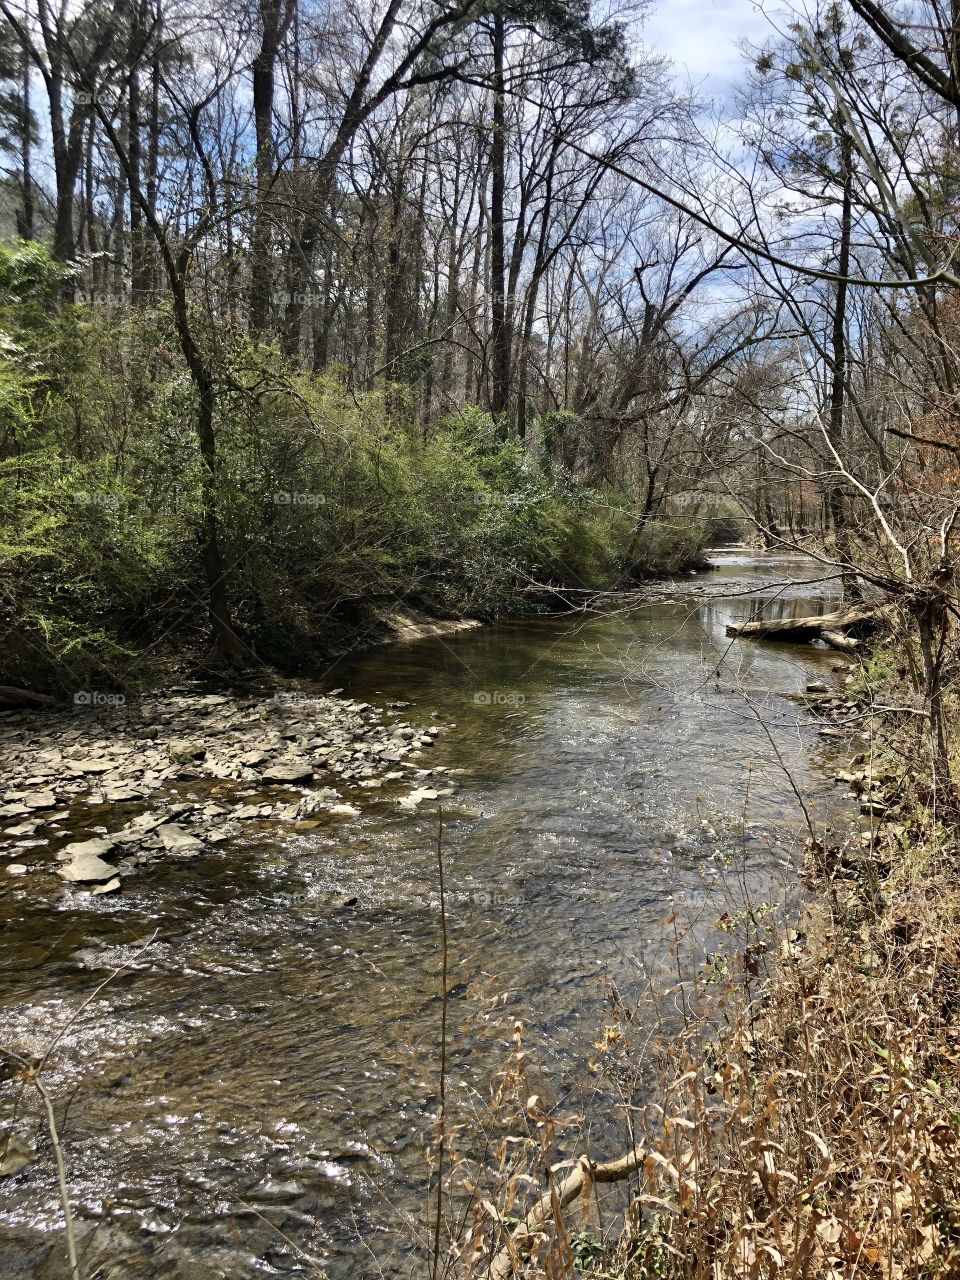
[{"xmin": 1, "ymin": 0, "xmax": 957, "ymax": 689}]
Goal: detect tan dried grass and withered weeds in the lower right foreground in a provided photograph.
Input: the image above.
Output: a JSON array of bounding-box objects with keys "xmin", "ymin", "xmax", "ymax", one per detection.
[{"xmin": 448, "ymin": 706, "xmax": 960, "ymax": 1280}]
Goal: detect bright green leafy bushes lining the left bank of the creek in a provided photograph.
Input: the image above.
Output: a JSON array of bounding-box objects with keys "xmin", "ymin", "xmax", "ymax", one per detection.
[{"xmin": 0, "ymin": 300, "xmax": 706, "ymax": 690}]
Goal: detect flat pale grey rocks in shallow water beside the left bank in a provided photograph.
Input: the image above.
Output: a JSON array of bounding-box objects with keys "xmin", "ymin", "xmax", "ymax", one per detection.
[{"xmin": 0, "ymin": 687, "xmax": 453, "ymax": 895}]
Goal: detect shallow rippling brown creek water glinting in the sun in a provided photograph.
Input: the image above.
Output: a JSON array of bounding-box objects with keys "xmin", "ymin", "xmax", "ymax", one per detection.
[{"xmin": 0, "ymin": 553, "xmax": 842, "ymax": 1280}]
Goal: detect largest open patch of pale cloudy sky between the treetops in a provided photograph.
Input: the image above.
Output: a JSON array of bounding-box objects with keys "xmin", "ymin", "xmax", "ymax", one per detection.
[{"xmin": 643, "ymin": 0, "xmax": 771, "ymax": 97}]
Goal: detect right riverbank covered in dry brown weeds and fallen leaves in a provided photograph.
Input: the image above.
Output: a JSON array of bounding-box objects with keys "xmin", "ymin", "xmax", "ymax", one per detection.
[{"xmin": 483, "ymin": 645, "xmax": 960, "ymax": 1280}]
